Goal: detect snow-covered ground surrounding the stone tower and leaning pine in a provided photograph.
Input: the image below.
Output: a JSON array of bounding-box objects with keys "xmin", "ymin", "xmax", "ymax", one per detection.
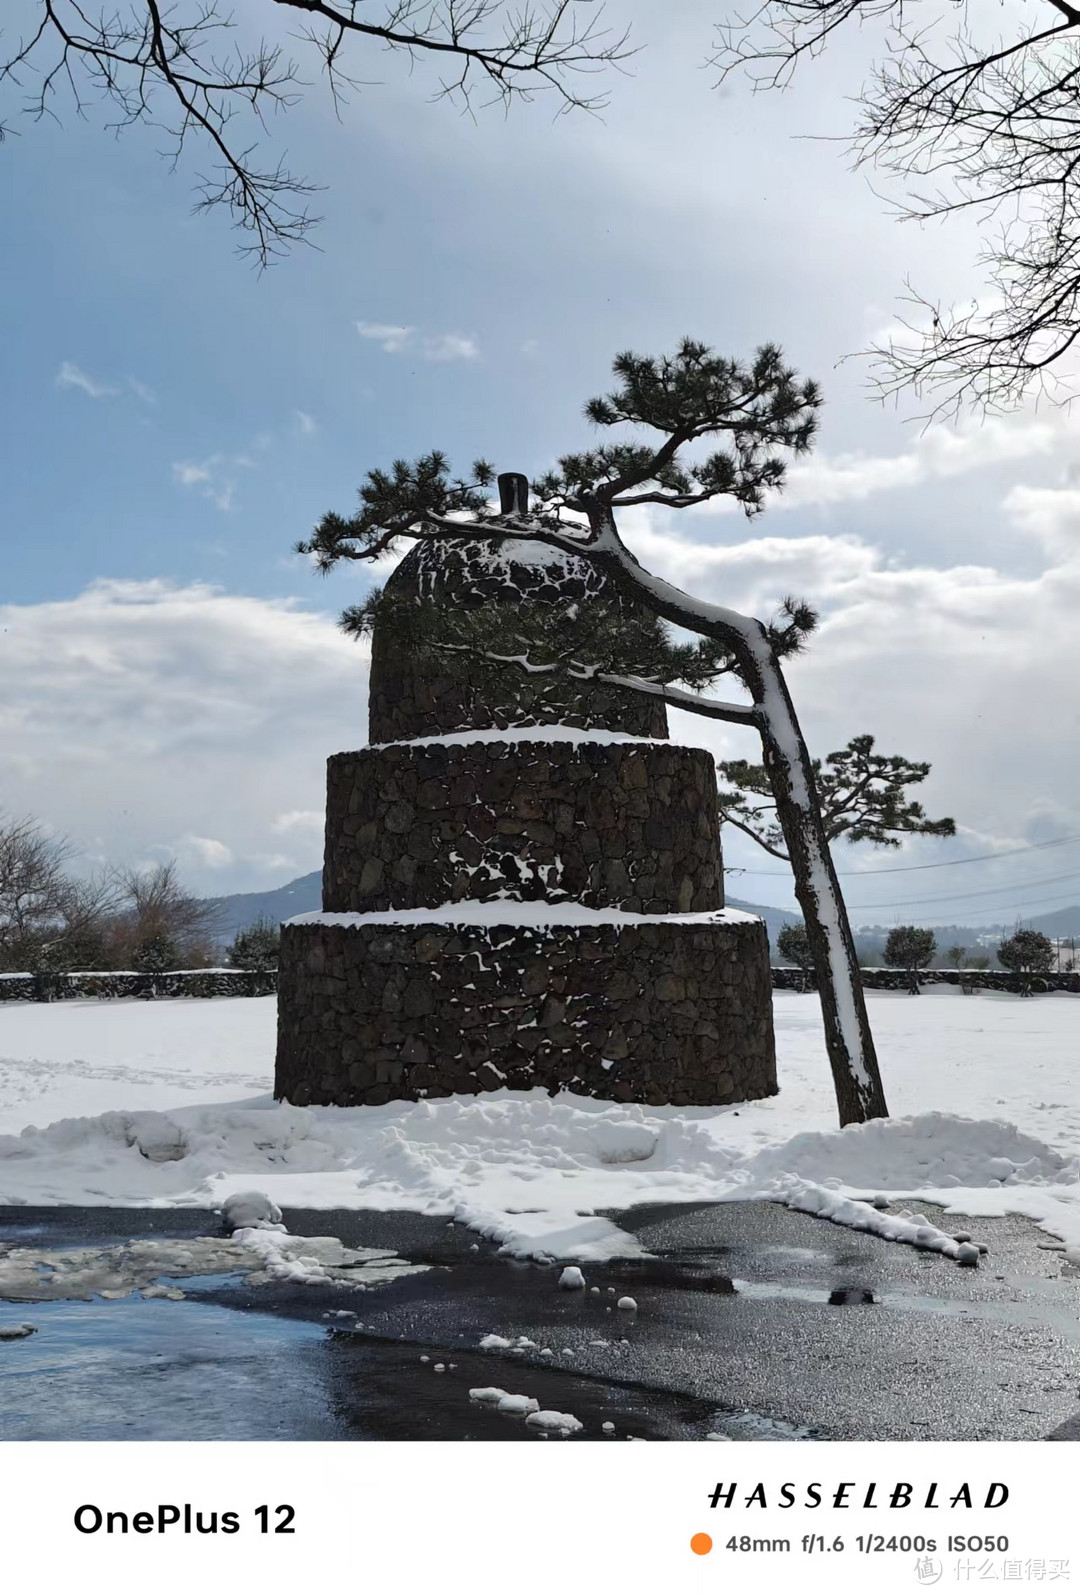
[{"xmin": 0, "ymin": 987, "xmax": 1080, "ymax": 1260}]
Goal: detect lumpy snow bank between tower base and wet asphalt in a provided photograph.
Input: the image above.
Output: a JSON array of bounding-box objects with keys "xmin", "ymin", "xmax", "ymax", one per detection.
[{"xmin": 0, "ymin": 1091, "xmax": 1080, "ymax": 1262}]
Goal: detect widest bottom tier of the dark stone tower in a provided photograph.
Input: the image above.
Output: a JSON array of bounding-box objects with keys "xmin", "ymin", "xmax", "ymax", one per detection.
[{"xmin": 274, "ymin": 920, "xmax": 777, "ymax": 1105}]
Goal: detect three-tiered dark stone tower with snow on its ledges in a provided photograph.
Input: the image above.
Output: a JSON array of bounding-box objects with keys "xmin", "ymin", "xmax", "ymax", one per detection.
[{"xmin": 274, "ymin": 541, "xmax": 777, "ymax": 1105}]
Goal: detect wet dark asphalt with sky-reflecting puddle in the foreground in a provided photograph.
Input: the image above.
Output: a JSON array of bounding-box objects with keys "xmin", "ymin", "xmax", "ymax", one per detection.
[{"xmin": 0, "ymin": 1203, "xmax": 1080, "ymax": 1440}]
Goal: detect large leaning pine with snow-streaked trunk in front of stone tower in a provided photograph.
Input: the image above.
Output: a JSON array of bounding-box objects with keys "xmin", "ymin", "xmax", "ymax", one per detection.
[{"xmin": 298, "ymin": 338, "xmax": 887, "ymax": 1124}]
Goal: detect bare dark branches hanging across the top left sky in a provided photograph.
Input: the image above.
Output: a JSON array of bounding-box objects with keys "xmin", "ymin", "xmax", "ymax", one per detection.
[{"xmin": 0, "ymin": 0, "xmax": 630, "ymax": 265}]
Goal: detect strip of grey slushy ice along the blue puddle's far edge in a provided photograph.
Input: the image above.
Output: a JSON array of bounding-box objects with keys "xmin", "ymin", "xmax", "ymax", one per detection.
[{"xmin": 0, "ymin": 1230, "xmax": 428, "ymax": 1302}]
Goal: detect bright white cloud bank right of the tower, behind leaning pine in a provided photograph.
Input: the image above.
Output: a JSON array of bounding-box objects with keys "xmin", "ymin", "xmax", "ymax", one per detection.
[{"xmin": 625, "ymin": 504, "xmax": 1080, "ymax": 922}]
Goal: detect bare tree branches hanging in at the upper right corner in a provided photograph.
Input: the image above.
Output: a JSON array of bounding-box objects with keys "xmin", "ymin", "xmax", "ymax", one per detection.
[{"xmin": 716, "ymin": 0, "xmax": 1080, "ymax": 415}]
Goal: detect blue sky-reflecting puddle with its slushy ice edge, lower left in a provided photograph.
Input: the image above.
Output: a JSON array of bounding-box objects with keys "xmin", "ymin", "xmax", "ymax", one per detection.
[{"xmin": 0, "ymin": 1230, "xmax": 428, "ymax": 1440}]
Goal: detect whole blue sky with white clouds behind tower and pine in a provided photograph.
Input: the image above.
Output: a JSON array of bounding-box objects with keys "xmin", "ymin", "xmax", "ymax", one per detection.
[{"xmin": 0, "ymin": 0, "xmax": 1080, "ymax": 924}]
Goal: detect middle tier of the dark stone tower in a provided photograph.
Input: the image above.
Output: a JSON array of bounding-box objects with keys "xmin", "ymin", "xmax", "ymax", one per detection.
[{"xmin": 322, "ymin": 742, "xmax": 724, "ymax": 914}]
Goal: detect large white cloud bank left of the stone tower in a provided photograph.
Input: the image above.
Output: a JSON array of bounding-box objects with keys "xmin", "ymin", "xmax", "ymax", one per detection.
[{"xmin": 0, "ymin": 582, "xmax": 367, "ymax": 895}]
